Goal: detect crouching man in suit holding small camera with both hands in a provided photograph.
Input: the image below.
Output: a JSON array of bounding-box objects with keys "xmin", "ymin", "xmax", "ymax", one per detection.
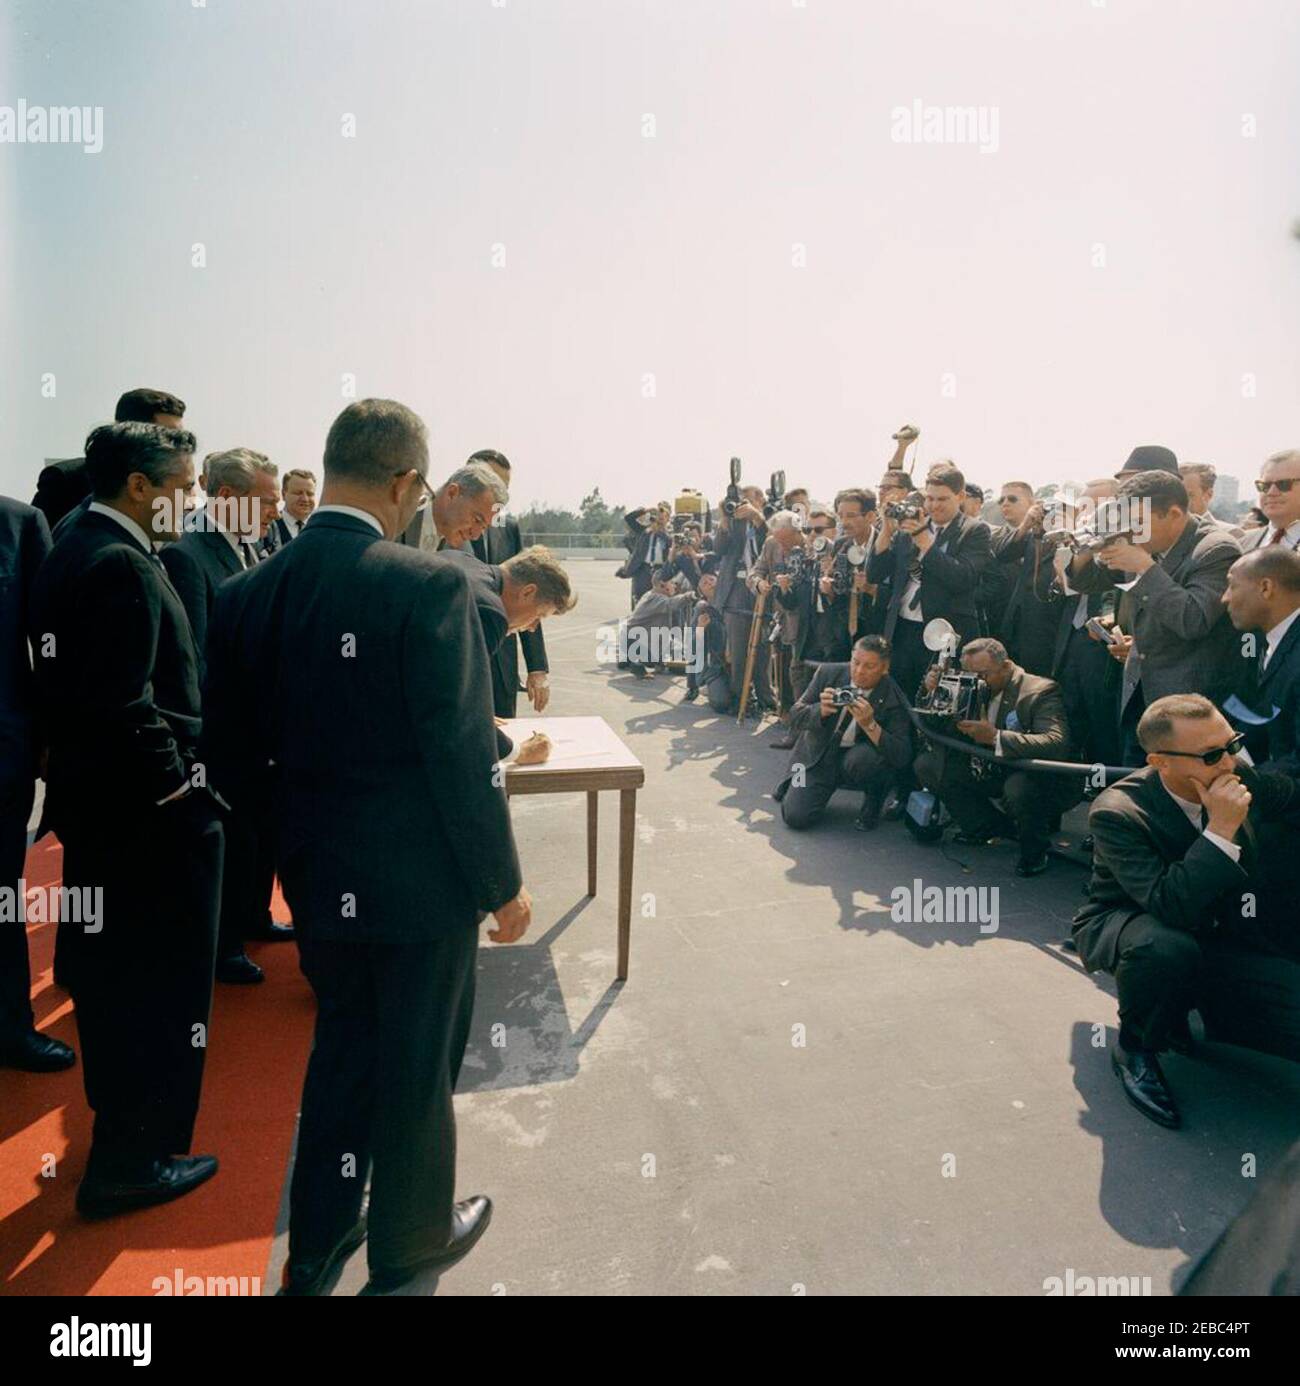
[{"xmin": 772, "ymin": 635, "xmax": 913, "ymax": 832}]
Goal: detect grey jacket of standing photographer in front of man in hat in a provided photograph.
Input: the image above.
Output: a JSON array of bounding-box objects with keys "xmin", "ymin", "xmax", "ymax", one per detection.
[{"xmin": 1070, "ymin": 517, "xmax": 1242, "ymax": 707}]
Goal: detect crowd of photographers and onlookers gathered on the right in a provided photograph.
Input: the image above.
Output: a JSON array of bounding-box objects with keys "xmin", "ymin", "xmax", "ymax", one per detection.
[{"xmin": 620, "ymin": 427, "xmax": 1300, "ymax": 1125}]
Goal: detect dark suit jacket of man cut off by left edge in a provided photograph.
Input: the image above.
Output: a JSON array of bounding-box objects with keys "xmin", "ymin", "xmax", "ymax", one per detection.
[{"xmin": 0, "ymin": 496, "xmax": 50, "ymax": 787}]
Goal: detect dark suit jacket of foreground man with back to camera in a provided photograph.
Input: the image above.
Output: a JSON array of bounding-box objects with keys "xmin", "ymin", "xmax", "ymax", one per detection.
[{"xmin": 204, "ymin": 510, "xmax": 520, "ymax": 942}]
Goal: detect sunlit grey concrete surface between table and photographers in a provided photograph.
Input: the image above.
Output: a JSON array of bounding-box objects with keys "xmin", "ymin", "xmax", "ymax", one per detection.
[{"xmin": 265, "ymin": 560, "xmax": 1300, "ymax": 1295}]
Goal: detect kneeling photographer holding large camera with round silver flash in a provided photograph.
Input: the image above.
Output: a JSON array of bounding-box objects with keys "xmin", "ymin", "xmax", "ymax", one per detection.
[{"xmin": 916, "ymin": 636, "xmax": 1084, "ymax": 876}]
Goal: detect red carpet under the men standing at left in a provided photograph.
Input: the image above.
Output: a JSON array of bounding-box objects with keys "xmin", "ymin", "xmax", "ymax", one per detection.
[{"xmin": 0, "ymin": 837, "xmax": 316, "ymax": 1295}]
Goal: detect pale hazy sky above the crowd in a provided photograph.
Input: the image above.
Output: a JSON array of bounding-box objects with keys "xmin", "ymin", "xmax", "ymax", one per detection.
[{"xmin": 0, "ymin": 0, "xmax": 1300, "ymax": 510}]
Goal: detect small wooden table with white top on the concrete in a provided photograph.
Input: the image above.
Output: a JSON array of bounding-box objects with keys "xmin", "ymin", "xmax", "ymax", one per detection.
[{"xmin": 504, "ymin": 717, "xmax": 646, "ymax": 981}]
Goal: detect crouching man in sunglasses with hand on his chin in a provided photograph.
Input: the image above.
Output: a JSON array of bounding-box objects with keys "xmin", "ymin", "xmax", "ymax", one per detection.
[{"xmin": 1074, "ymin": 693, "xmax": 1300, "ymax": 1127}]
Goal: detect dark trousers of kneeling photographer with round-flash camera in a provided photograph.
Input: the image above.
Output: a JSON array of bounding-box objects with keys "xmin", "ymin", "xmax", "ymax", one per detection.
[{"xmin": 916, "ymin": 750, "xmax": 1084, "ymax": 858}]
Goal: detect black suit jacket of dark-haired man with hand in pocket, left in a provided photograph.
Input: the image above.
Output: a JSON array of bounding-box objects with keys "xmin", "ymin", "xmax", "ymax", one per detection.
[{"xmin": 32, "ymin": 511, "xmax": 200, "ymax": 836}]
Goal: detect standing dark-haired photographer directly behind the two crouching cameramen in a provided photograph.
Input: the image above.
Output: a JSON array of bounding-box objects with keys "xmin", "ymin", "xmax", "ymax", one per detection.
[{"xmin": 868, "ymin": 462, "xmax": 992, "ymax": 697}]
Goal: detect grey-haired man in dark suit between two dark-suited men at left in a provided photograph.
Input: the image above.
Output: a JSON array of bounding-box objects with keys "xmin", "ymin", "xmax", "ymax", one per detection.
[{"xmin": 161, "ymin": 448, "xmax": 294, "ymax": 985}]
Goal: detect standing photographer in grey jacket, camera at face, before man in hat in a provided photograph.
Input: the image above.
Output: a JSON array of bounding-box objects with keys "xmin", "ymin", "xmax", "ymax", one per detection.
[{"xmin": 1069, "ymin": 467, "xmax": 1242, "ymax": 765}]
